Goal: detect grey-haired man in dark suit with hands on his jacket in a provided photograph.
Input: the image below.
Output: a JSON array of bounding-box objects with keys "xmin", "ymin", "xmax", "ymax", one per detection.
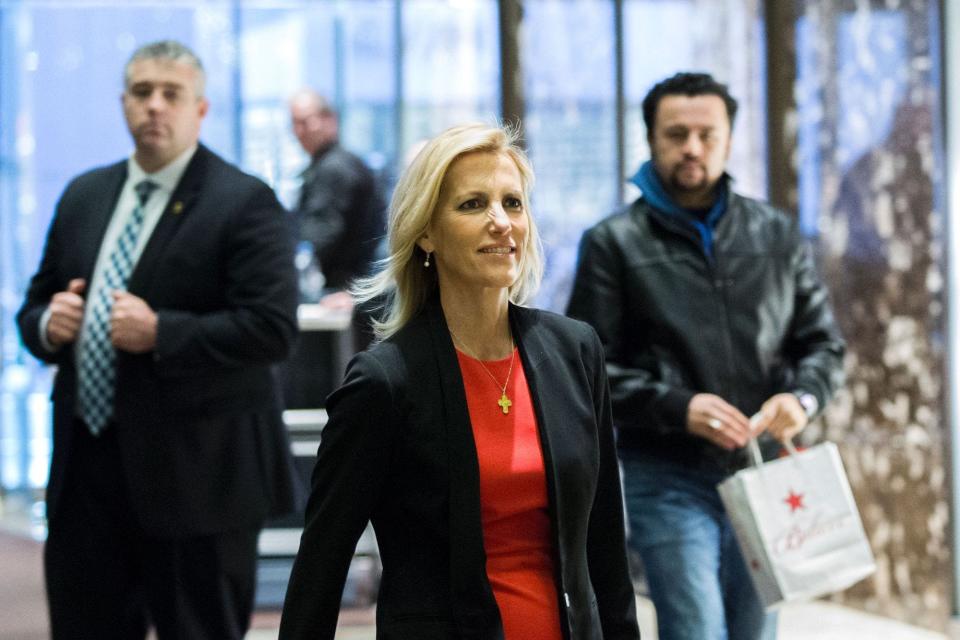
[{"xmin": 17, "ymin": 41, "xmax": 296, "ymax": 639}]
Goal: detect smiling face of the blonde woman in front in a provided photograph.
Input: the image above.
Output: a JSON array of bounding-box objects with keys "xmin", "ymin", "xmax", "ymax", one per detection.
[{"xmin": 419, "ymin": 151, "xmax": 528, "ymax": 290}]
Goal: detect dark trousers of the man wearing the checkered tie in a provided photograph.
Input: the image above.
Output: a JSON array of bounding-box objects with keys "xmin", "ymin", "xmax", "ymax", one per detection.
[{"xmin": 44, "ymin": 422, "xmax": 259, "ymax": 640}]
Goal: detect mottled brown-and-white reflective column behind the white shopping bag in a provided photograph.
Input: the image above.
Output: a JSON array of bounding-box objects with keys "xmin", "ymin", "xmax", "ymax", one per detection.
[{"xmin": 793, "ymin": 0, "xmax": 951, "ymax": 630}]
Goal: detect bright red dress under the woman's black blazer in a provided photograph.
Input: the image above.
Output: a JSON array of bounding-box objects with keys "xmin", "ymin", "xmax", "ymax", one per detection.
[{"xmin": 457, "ymin": 350, "xmax": 563, "ymax": 640}]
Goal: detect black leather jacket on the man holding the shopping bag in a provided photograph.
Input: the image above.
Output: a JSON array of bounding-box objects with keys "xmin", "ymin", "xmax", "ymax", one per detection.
[{"xmin": 567, "ymin": 191, "xmax": 844, "ymax": 472}]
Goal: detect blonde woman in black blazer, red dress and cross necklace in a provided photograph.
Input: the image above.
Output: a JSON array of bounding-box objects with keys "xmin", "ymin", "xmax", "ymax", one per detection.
[{"xmin": 280, "ymin": 124, "xmax": 639, "ymax": 640}]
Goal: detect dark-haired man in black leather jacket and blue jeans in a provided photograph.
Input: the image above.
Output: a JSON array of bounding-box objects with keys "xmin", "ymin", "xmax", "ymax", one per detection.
[{"xmin": 567, "ymin": 73, "xmax": 844, "ymax": 640}]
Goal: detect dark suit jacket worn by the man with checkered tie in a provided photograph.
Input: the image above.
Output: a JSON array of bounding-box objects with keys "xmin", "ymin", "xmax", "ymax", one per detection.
[{"xmin": 17, "ymin": 146, "xmax": 297, "ymax": 536}]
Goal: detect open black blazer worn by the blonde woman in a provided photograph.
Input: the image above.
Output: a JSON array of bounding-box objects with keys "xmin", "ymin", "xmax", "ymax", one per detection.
[{"xmin": 280, "ymin": 298, "xmax": 639, "ymax": 640}]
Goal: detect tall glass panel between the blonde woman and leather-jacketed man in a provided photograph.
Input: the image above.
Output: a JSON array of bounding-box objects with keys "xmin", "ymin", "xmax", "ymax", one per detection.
[{"xmin": 521, "ymin": 0, "xmax": 618, "ymax": 311}]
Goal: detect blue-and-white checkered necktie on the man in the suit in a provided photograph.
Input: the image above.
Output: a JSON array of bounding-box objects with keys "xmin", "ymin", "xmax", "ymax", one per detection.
[{"xmin": 78, "ymin": 180, "xmax": 158, "ymax": 435}]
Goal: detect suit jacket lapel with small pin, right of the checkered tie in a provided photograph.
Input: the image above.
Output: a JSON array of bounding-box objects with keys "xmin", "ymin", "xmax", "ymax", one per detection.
[{"xmin": 128, "ymin": 145, "xmax": 210, "ymax": 293}]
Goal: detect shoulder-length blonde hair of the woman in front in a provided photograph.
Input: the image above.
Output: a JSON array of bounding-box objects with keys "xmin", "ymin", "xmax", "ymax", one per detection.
[{"xmin": 352, "ymin": 123, "xmax": 543, "ymax": 340}]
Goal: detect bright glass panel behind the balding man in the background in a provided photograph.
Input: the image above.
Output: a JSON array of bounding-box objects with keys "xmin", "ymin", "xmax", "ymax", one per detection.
[{"xmin": 238, "ymin": 0, "xmax": 397, "ymax": 206}]
